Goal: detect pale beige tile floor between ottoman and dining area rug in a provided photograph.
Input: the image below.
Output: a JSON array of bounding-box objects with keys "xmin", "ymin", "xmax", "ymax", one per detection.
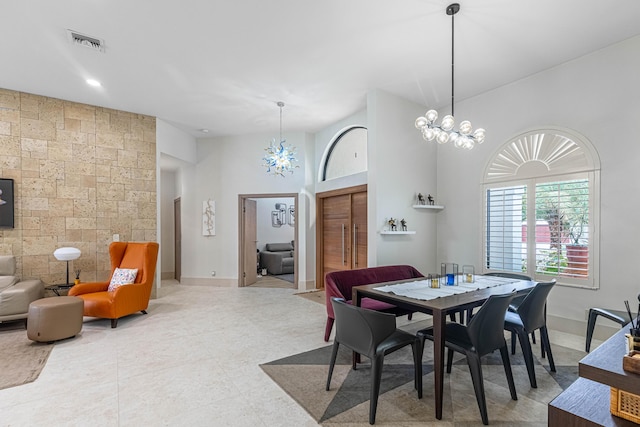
[{"xmin": 0, "ymin": 282, "xmax": 598, "ymax": 427}]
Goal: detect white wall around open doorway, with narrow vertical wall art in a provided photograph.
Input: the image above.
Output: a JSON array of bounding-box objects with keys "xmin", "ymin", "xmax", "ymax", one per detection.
[{"xmin": 183, "ymin": 133, "xmax": 315, "ymax": 288}]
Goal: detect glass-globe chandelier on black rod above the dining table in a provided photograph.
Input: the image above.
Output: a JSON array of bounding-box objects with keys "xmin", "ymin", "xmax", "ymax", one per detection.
[{"xmin": 416, "ymin": 3, "xmax": 485, "ymax": 150}]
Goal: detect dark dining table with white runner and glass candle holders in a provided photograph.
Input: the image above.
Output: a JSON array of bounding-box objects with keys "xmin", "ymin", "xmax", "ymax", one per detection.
[{"xmin": 352, "ymin": 275, "xmax": 536, "ymax": 420}]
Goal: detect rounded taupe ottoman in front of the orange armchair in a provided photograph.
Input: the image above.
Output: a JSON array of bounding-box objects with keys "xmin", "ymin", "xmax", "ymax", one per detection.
[{"xmin": 27, "ymin": 296, "xmax": 84, "ymax": 342}]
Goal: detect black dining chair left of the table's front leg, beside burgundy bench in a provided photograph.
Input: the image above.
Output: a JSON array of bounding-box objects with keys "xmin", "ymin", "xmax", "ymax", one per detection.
[{"xmin": 326, "ymin": 297, "xmax": 422, "ymax": 424}]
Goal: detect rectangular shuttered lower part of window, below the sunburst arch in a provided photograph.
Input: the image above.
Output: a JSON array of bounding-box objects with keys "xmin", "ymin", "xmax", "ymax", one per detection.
[{"xmin": 484, "ymin": 174, "xmax": 592, "ymax": 285}]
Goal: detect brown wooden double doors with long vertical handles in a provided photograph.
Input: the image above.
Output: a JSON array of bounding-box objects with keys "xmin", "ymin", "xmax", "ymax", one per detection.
[{"xmin": 316, "ymin": 185, "xmax": 367, "ymax": 288}]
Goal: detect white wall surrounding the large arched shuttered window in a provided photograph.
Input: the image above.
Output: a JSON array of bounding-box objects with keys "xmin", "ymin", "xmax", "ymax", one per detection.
[{"xmin": 438, "ymin": 37, "xmax": 640, "ymax": 327}]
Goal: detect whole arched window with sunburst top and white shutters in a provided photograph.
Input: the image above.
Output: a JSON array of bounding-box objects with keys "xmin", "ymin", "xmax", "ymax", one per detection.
[{"xmin": 483, "ymin": 130, "xmax": 600, "ymax": 287}]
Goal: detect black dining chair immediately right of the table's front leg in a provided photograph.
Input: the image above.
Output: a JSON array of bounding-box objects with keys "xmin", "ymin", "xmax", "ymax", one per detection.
[{"xmin": 417, "ymin": 294, "xmax": 518, "ymax": 425}]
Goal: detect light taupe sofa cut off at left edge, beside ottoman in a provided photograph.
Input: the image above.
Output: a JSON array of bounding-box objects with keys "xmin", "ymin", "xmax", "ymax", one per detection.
[{"xmin": 0, "ymin": 255, "xmax": 44, "ymax": 322}]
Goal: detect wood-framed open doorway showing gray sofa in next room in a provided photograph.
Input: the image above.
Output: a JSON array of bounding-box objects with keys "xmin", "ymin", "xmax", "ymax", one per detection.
[{"xmin": 238, "ymin": 193, "xmax": 298, "ymax": 289}]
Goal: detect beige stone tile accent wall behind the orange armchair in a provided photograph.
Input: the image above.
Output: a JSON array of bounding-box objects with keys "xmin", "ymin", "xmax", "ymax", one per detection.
[{"xmin": 0, "ymin": 89, "xmax": 157, "ymax": 284}]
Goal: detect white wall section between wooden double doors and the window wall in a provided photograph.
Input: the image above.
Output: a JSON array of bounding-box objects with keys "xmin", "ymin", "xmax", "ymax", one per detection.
[{"xmin": 367, "ymin": 90, "xmax": 442, "ymax": 275}]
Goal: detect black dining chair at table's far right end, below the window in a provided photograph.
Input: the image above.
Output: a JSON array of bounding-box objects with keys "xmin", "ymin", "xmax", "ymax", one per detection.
[{"xmin": 504, "ymin": 279, "xmax": 556, "ymax": 388}]
